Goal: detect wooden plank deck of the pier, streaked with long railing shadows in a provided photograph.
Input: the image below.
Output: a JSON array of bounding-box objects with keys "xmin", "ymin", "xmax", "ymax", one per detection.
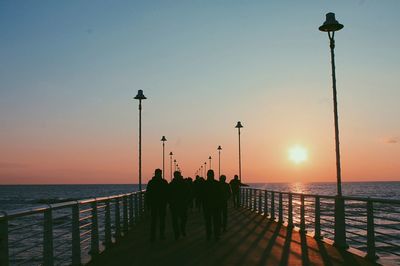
[{"xmin": 89, "ymin": 206, "xmax": 376, "ymax": 266}]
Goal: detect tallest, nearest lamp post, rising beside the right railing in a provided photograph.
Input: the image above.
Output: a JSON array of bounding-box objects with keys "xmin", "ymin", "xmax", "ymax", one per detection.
[{"xmin": 319, "ymin": 13, "xmax": 347, "ymax": 248}]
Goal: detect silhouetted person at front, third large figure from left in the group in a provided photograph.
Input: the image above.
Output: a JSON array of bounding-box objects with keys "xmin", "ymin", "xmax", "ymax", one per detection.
[{"xmin": 202, "ymin": 169, "xmax": 223, "ymax": 240}]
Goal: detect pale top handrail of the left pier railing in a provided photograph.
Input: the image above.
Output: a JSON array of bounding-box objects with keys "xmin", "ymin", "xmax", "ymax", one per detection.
[{"xmin": 0, "ymin": 190, "xmax": 146, "ymax": 220}]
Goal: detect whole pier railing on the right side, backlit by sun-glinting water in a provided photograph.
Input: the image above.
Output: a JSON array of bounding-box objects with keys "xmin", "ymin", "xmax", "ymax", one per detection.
[{"xmin": 241, "ymin": 188, "xmax": 400, "ymax": 263}]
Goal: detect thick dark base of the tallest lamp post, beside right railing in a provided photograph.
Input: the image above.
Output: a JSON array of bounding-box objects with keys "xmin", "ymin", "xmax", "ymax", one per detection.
[{"xmin": 333, "ymin": 196, "xmax": 348, "ymax": 249}]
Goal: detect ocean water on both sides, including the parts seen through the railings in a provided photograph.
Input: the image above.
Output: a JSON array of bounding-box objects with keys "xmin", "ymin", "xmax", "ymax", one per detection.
[{"xmin": 0, "ymin": 182, "xmax": 400, "ymax": 265}]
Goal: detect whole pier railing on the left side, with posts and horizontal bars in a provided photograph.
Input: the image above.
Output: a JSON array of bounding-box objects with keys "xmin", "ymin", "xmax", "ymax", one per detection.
[{"xmin": 0, "ymin": 191, "xmax": 145, "ymax": 266}]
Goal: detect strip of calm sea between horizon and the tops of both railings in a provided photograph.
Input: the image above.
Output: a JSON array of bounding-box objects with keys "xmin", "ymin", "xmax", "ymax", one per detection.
[{"xmin": 0, "ymin": 182, "xmax": 400, "ymax": 211}]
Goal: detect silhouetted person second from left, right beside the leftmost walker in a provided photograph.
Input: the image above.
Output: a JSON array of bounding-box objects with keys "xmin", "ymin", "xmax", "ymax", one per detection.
[{"xmin": 169, "ymin": 171, "xmax": 189, "ymax": 240}]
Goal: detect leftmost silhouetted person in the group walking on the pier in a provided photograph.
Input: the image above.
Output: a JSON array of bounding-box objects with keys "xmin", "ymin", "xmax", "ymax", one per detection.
[{"xmin": 145, "ymin": 169, "xmax": 168, "ymax": 242}]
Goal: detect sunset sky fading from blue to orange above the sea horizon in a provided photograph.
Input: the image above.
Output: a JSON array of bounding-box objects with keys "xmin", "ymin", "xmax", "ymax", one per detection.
[{"xmin": 0, "ymin": 0, "xmax": 400, "ymax": 184}]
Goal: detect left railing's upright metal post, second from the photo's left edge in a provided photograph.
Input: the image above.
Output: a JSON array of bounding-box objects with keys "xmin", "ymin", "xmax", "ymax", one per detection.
[{"xmin": 43, "ymin": 206, "xmax": 54, "ymax": 266}]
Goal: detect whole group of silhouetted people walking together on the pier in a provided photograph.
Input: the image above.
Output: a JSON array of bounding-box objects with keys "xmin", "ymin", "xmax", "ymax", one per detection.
[{"xmin": 146, "ymin": 169, "xmax": 246, "ymax": 242}]
